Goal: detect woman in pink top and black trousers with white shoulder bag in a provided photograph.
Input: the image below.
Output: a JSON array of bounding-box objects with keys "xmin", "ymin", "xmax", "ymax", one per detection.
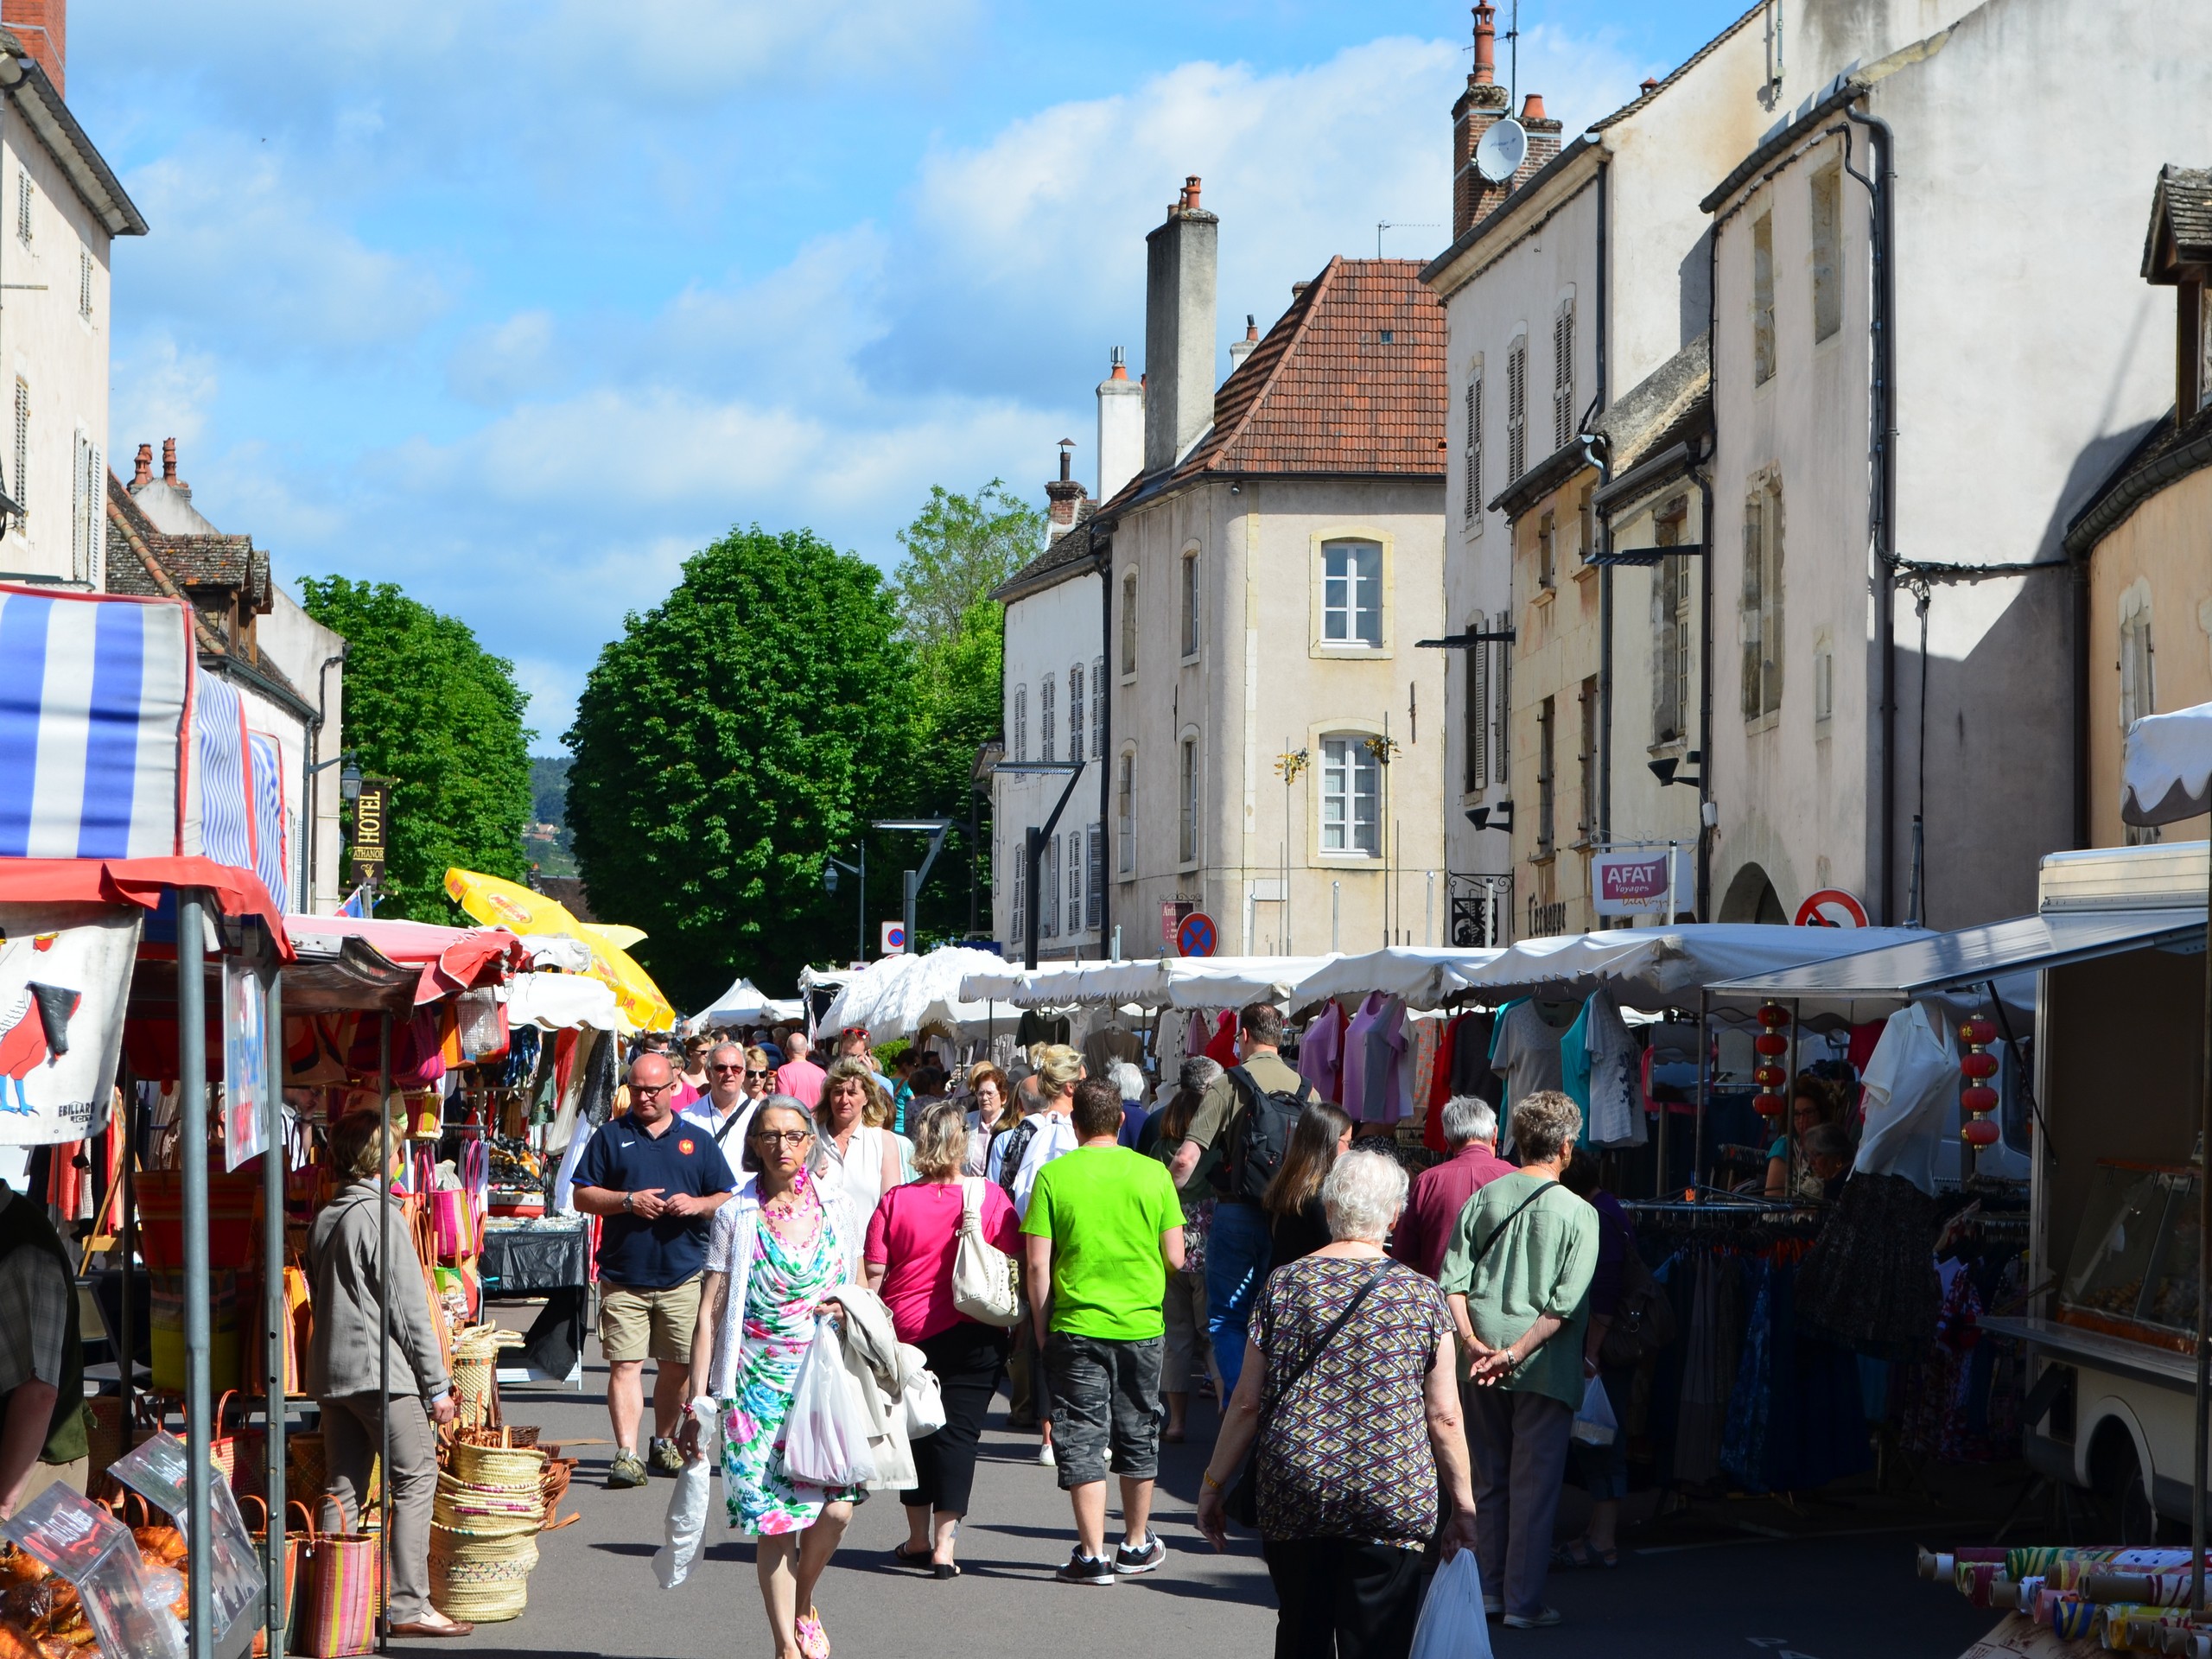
[{"xmin": 862, "ymin": 1099, "xmax": 1022, "ymax": 1580}]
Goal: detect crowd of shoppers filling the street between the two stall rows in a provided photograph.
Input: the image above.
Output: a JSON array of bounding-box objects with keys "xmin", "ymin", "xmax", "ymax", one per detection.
[{"xmin": 480, "ymin": 1002, "xmax": 1672, "ymax": 1659}]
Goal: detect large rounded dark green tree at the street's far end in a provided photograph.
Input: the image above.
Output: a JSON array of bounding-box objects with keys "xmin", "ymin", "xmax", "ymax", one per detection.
[{"xmin": 564, "ymin": 524, "xmax": 916, "ymax": 1007}]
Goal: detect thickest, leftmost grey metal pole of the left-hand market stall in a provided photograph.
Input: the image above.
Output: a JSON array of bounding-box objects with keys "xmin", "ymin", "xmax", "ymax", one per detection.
[{"xmin": 178, "ymin": 887, "xmax": 214, "ymax": 1659}]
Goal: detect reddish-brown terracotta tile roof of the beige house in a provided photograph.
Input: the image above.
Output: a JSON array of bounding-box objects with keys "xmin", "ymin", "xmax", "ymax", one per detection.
[{"xmin": 1176, "ymin": 254, "xmax": 1446, "ymax": 480}]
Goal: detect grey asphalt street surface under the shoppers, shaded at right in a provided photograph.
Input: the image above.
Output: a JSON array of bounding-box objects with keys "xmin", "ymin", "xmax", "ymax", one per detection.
[{"xmin": 396, "ymin": 1336, "xmax": 2025, "ymax": 1659}]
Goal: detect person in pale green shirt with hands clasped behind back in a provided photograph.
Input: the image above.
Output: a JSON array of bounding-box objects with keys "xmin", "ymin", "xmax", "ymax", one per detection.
[{"xmin": 1440, "ymin": 1089, "xmax": 1597, "ymax": 1630}]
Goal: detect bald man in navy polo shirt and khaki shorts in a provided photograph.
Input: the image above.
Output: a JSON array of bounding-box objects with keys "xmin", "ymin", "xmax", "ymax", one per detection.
[{"xmin": 575, "ymin": 1051, "xmax": 736, "ymax": 1486}]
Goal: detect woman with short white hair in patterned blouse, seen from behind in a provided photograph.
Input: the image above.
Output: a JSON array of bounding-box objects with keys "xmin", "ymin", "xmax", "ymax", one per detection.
[{"xmin": 1199, "ymin": 1150, "xmax": 1476, "ymax": 1659}]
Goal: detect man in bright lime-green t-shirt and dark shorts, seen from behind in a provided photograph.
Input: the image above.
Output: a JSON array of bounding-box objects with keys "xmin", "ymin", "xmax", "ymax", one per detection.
[{"xmin": 1022, "ymin": 1077, "xmax": 1184, "ymax": 1584}]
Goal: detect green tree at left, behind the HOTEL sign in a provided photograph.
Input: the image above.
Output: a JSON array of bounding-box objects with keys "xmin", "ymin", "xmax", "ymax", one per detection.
[{"xmin": 299, "ymin": 575, "xmax": 536, "ymax": 923}]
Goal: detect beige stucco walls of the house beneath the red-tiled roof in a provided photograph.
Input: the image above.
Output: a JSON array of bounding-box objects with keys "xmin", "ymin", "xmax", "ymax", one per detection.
[{"xmin": 1110, "ymin": 475, "xmax": 1445, "ymax": 956}]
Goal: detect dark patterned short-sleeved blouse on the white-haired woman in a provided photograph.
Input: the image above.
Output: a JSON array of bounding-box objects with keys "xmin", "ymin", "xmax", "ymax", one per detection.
[{"xmin": 1252, "ymin": 1256, "xmax": 1451, "ymax": 1544}]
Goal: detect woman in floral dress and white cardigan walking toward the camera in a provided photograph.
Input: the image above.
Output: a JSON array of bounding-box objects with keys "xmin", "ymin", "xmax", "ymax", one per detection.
[{"xmin": 679, "ymin": 1095, "xmax": 861, "ymax": 1659}]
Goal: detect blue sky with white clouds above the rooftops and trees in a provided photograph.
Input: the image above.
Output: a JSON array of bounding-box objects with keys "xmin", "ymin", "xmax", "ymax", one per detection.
[{"xmin": 68, "ymin": 0, "xmax": 1747, "ymax": 754}]
